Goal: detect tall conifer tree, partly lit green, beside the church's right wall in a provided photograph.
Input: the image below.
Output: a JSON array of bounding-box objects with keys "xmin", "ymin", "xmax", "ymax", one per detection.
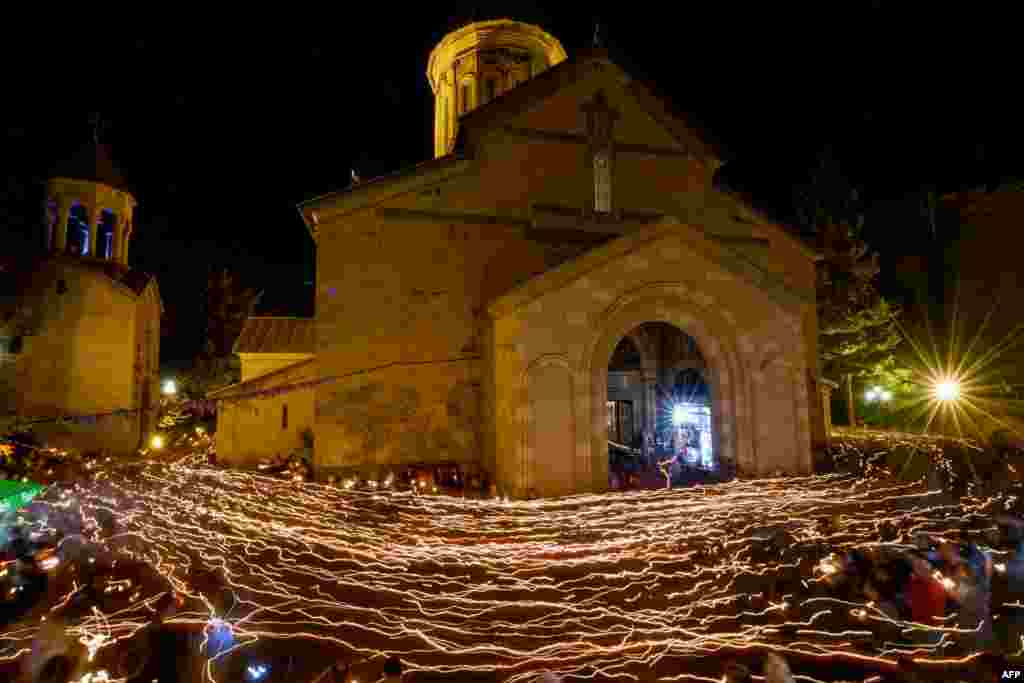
[{"xmin": 794, "ymin": 147, "xmax": 902, "ymax": 425}]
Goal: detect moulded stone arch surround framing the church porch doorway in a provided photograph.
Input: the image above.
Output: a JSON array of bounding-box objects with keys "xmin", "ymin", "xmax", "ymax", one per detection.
[{"xmin": 578, "ymin": 284, "xmax": 754, "ymax": 493}]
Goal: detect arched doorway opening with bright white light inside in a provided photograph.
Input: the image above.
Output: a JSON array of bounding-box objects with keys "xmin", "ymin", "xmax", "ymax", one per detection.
[{"xmin": 604, "ymin": 322, "xmax": 718, "ymax": 488}]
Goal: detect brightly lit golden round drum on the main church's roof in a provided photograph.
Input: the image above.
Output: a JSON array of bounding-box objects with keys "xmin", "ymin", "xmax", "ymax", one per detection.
[{"xmin": 427, "ymin": 19, "xmax": 565, "ymax": 157}]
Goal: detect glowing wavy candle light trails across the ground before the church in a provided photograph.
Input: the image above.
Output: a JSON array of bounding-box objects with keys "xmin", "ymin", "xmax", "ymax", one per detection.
[{"xmin": 0, "ymin": 440, "xmax": 1012, "ymax": 683}]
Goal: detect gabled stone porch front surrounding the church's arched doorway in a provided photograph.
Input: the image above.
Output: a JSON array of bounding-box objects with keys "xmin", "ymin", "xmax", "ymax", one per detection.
[{"xmin": 494, "ymin": 225, "xmax": 810, "ymax": 496}]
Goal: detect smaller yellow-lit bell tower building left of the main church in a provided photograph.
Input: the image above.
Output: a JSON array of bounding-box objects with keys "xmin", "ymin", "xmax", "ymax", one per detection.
[{"xmin": 0, "ymin": 140, "xmax": 163, "ymax": 455}]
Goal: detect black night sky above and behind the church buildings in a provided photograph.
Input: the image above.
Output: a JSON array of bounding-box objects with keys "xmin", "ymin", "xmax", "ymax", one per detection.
[{"xmin": 0, "ymin": 2, "xmax": 1020, "ymax": 360}]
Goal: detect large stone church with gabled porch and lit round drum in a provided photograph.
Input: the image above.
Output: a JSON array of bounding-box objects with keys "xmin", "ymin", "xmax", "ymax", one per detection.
[{"xmin": 216, "ymin": 19, "xmax": 824, "ymax": 497}]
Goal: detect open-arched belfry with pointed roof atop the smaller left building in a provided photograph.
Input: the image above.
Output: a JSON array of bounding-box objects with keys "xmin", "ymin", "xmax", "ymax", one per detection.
[{"xmin": 43, "ymin": 135, "xmax": 137, "ymax": 268}]
